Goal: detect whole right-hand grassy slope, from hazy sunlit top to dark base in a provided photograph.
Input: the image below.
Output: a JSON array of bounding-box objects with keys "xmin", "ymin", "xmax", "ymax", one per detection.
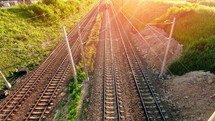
[{"xmin": 122, "ymin": 1, "xmax": 215, "ymax": 75}]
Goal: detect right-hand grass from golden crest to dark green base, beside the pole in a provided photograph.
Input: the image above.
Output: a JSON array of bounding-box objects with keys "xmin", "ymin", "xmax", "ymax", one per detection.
[{"xmin": 156, "ymin": 5, "xmax": 215, "ymax": 75}]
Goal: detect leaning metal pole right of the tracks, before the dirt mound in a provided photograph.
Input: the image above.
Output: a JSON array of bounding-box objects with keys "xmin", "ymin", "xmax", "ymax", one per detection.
[{"xmin": 159, "ymin": 17, "xmax": 176, "ymax": 77}]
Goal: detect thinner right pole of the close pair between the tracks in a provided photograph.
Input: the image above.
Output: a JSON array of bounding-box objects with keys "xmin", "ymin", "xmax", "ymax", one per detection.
[{"xmin": 77, "ymin": 22, "xmax": 89, "ymax": 81}]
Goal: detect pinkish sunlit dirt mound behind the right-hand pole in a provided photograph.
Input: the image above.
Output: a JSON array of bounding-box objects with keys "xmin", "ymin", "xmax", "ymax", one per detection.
[{"xmin": 131, "ymin": 26, "xmax": 183, "ymax": 72}]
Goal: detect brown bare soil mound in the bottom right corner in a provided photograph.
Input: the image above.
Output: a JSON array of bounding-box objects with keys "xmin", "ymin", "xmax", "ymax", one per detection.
[{"xmin": 160, "ymin": 71, "xmax": 215, "ymax": 121}]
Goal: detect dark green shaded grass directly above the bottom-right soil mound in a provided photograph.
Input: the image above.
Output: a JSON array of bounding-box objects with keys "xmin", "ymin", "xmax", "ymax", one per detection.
[{"xmin": 169, "ymin": 36, "xmax": 215, "ymax": 75}]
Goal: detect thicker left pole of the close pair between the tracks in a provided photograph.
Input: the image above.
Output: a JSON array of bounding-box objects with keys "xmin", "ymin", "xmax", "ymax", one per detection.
[{"xmin": 63, "ymin": 26, "xmax": 77, "ymax": 82}]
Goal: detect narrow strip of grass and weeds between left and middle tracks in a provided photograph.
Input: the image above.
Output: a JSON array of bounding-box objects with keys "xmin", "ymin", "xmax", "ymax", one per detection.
[{"xmin": 68, "ymin": 17, "xmax": 101, "ymax": 121}]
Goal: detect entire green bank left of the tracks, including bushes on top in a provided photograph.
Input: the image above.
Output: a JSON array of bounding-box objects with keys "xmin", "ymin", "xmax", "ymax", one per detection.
[{"xmin": 0, "ymin": 0, "xmax": 96, "ymax": 89}]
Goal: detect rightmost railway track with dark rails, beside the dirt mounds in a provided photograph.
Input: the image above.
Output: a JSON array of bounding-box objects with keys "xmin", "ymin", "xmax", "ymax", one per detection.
[{"xmin": 112, "ymin": 2, "xmax": 168, "ymax": 121}]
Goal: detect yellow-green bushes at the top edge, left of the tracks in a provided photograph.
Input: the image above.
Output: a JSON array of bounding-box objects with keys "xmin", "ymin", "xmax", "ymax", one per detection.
[{"xmin": 19, "ymin": 0, "xmax": 79, "ymax": 21}]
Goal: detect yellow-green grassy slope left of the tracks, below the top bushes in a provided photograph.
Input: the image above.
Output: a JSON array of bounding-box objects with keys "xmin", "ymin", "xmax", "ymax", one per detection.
[{"xmin": 0, "ymin": 1, "xmax": 95, "ymax": 89}]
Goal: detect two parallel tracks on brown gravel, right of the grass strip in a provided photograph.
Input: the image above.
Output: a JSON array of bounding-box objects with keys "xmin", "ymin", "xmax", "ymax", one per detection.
[{"xmin": 91, "ymin": 1, "xmax": 167, "ymax": 121}]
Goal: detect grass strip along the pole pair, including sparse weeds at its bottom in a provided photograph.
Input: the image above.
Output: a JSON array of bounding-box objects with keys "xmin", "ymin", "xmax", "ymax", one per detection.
[{"xmin": 53, "ymin": 10, "xmax": 101, "ymax": 121}]
